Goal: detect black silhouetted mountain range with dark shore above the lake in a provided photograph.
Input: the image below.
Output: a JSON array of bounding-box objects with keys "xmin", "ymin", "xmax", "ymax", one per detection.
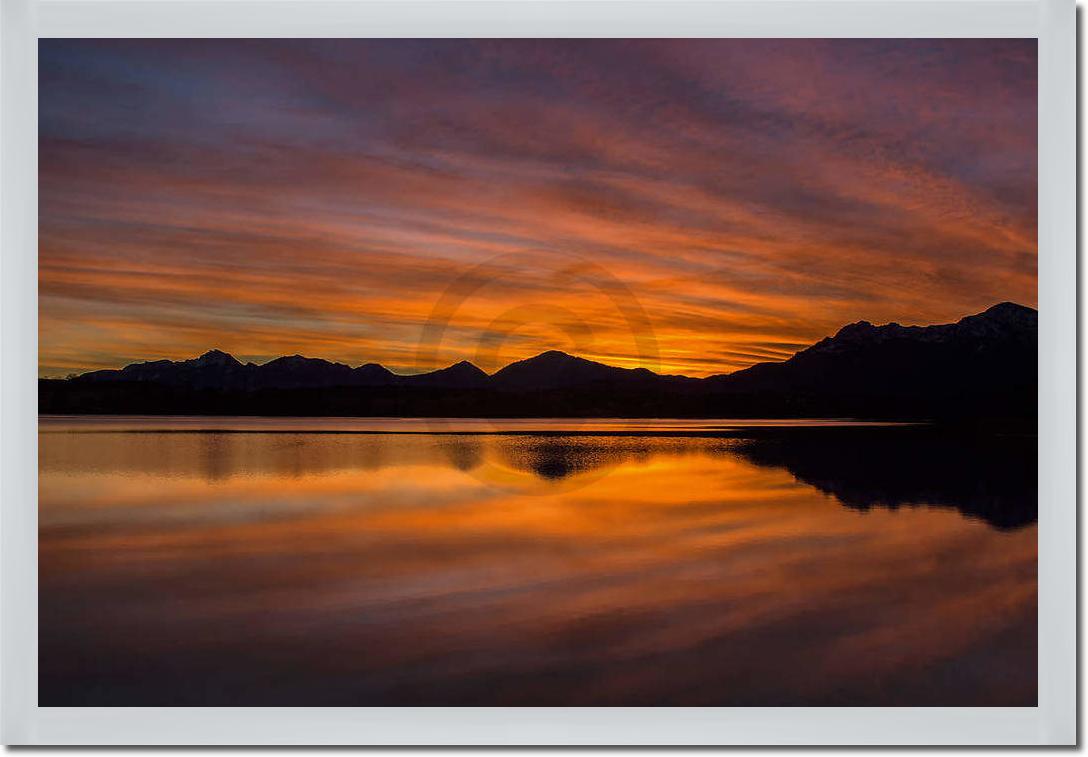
[{"xmin": 39, "ymin": 302, "xmax": 1038, "ymax": 420}]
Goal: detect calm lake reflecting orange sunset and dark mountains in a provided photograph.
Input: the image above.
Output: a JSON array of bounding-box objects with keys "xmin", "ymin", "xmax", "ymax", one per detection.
[{"xmin": 39, "ymin": 418, "xmax": 1037, "ymax": 706}]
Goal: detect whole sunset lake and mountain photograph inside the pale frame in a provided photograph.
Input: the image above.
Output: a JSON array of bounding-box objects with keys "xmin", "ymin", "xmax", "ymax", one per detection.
[{"xmin": 37, "ymin": 38, "xmax": 1039, "ymax": 707}]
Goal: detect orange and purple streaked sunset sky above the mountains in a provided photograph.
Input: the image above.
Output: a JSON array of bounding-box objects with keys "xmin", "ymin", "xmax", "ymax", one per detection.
[{"xmin": 38, "ymin": 39, "xmax": 1036, "ymax": 376}]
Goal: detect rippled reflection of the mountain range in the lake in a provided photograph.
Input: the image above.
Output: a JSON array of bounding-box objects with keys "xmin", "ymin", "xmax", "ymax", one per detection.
[{"xmin": 40, "ymin": 426, "xmax": 1038, "ymax": 529}]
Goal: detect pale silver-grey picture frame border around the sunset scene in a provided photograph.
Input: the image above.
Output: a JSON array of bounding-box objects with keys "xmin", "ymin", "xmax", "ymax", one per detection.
[{"xmin": 0, "ymin": 0, "xmax": 1077, "ymax": 745}]
